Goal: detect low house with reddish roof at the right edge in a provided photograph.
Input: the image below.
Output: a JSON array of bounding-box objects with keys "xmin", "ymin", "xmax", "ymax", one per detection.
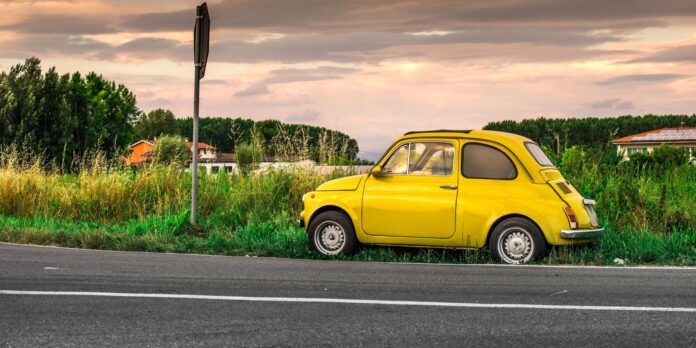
[{"xmin": 612, "ymin": 127, "xmax": 696, "ymax": 160}]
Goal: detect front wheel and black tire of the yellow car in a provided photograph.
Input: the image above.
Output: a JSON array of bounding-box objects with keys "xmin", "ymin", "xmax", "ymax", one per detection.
[{"xmin": 307, "ymin": 211, "xmax": 358, "ymax": 256}]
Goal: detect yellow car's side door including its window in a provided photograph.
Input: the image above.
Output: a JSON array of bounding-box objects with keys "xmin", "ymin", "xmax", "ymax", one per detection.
[{"xmin": 362, "ymin": 140, "xmax": 458, "ymax": 238}]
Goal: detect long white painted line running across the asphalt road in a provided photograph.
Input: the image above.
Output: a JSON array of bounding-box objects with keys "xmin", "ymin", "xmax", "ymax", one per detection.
[{"xmin": 0, "ymin": 290, "xmax": 696, "ymax": 313}]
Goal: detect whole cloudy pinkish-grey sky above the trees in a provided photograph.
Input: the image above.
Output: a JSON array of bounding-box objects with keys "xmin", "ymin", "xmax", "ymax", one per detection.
[{"xmin": 0, "ymin": 0, "xmax": 696, "ymax": 158}]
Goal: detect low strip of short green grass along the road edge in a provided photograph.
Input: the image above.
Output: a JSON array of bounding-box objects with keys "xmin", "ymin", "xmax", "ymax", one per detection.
[{"xmin": 0, "ymin": 216, "xmax": 696, "ymax": 266}]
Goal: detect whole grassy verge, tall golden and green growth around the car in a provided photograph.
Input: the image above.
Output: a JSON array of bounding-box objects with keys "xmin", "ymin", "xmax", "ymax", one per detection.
[{"xmin": 0, "ymin": 148, "xmax": 696, "ymax": 265}]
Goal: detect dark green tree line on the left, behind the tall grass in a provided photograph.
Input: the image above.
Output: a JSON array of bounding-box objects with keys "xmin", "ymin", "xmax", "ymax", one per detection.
[{"xmin": 0, "ymin": 57, "xmax": 358, "ymax": 168}]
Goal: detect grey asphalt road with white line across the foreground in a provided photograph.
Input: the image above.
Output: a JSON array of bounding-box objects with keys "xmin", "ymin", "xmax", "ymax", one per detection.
[{"xmin": 0, "ymin": 243, "xmax": 696, "ymax": 347}]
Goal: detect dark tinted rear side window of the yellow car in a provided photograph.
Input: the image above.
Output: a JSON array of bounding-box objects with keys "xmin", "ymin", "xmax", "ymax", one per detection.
[{"xmin": 462, "ymin": 143, "xmax": 517, "ymax": 180}]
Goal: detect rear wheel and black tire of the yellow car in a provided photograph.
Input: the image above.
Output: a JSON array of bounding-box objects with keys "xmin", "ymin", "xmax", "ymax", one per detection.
[{"xmin": 488, "ymin": 217, "xmax": 546, "ymax": 264}]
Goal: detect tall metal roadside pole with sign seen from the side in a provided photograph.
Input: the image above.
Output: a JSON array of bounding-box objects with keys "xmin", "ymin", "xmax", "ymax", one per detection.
[{"xmin": 191, "ymin": 3, "xmax": 210, "ymax": 225}]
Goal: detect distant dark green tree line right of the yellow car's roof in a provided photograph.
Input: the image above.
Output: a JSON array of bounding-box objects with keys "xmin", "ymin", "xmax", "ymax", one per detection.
[{"xmin": 483, "ymin": 114, "xmax": 696, "ymax": 152}]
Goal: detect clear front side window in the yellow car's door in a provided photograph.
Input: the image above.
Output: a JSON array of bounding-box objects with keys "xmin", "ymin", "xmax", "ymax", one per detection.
[{"xmin": 382, "ymin": 142, "xmax": 454, "ymax": 176}]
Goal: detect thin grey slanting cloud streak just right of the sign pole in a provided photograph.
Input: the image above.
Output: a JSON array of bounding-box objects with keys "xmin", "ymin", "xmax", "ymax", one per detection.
[{"xmin": 234, "ymin": 66, "xmax": 356, "ymax": 97}]
